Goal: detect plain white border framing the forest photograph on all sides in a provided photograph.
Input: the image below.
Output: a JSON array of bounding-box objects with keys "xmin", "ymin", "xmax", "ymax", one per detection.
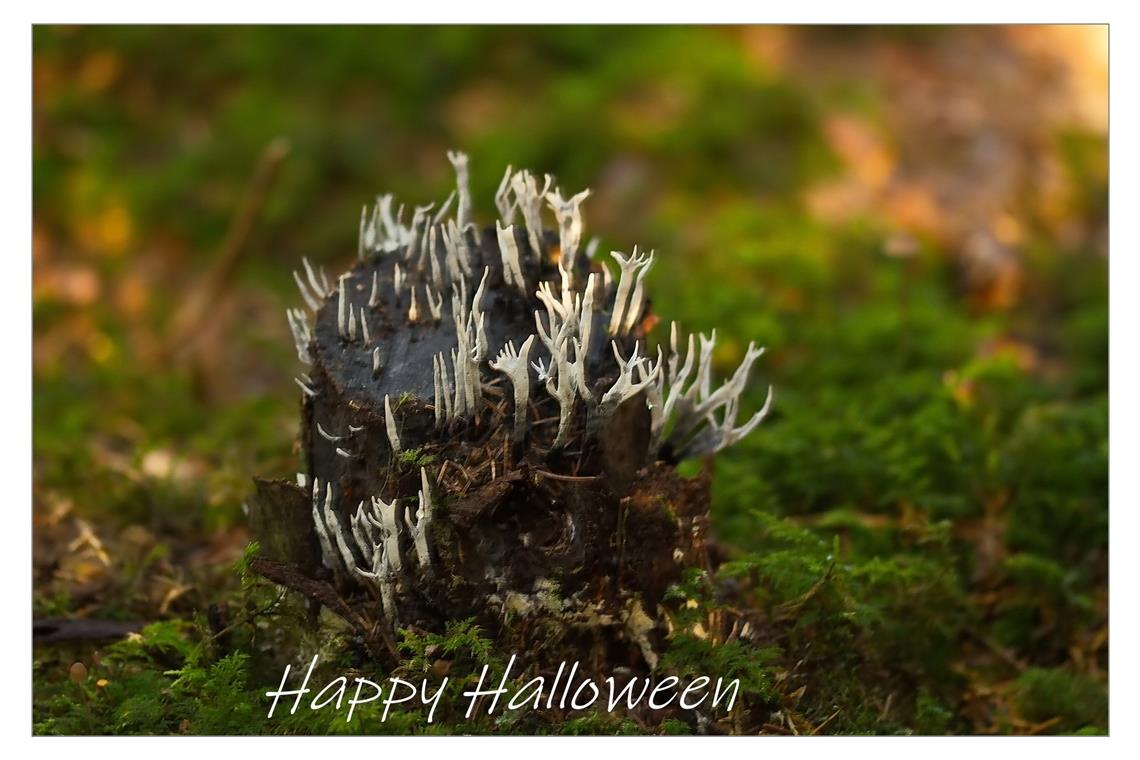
[{"xmin": 0, "ymin": 0, "xmax": 1140, "ymax": 760}]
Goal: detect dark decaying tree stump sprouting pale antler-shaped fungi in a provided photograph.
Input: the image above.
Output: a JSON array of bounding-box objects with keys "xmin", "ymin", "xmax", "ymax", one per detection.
[{"xmin": 250, "ymin": 153, "xmax": 772, "ymax": 671}]
